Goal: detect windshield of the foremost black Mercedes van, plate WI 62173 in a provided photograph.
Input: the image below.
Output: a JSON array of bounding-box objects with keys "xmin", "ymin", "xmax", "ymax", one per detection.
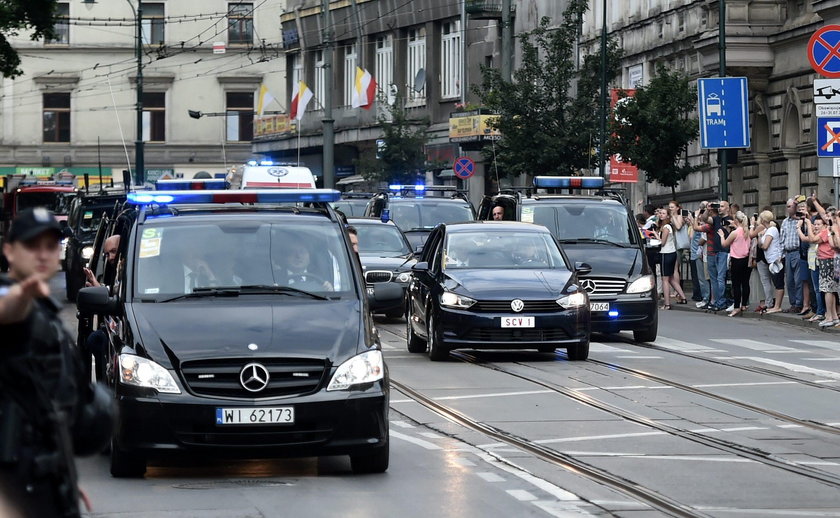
[{"xmin": 134, "ymin": 219, "xmax": 354, "ymax": 301}]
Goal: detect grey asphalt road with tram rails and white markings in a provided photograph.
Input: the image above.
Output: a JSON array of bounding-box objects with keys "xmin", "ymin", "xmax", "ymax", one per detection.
[{"xmin": 46, "ymin": 279, "xmax": 840, "ymax": 518}]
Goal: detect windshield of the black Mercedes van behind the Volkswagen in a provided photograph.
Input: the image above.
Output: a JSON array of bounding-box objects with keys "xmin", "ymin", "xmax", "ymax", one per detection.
[{"xmin": 522, "ymin": 202, "xmax": 638, "ymax": 245}]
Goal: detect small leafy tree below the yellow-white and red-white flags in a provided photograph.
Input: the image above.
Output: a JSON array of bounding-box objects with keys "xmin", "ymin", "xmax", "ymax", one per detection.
[{"xmin": 356, "ymin": 95, "xmax": 429, "ymax": 183}]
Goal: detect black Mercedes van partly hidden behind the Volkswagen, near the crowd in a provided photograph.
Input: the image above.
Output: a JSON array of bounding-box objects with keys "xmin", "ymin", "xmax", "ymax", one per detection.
[{"xmin": 479, "ymin": 176, "xmax": 659, "ymax": 342}]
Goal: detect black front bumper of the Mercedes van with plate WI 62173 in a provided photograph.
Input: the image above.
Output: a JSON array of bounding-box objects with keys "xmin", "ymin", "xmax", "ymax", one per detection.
[{"xmin": 115, "ymin": 380, "xmax": 389, "ymax": 459}]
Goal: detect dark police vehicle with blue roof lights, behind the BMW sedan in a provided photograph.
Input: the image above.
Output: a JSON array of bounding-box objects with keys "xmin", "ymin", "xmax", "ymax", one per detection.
[{"xmin": 365, "ymin": 185, "xmax": 475, "ymax": 252}]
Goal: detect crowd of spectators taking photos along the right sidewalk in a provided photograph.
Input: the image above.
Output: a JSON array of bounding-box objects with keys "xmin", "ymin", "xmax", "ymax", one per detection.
[{"xmin": 636, "ymin": 193, "xmax": 840, "ymax": 327}]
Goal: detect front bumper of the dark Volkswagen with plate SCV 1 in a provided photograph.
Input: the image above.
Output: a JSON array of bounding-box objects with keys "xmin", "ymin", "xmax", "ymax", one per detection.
[{"xmin": 438, "ymin": 308, "xmax": 590, "ymax": 349}]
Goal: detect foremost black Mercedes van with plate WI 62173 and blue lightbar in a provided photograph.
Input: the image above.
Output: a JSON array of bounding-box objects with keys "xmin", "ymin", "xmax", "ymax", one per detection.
[{"xmin": 78, "ymin": 189, "xmax": 402, "ymax": 476}]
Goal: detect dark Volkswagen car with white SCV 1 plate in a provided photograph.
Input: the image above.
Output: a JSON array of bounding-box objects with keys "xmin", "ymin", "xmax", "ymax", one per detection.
[{"xmin": 406, "ymin": 221, "xmax": 590, "ymax": 361}]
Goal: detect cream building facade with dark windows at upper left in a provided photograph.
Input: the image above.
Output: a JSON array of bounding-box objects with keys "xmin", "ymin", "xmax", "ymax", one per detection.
[{"xmin": 0, "ymin": 0, "xmax": 285, "ymax": 185}]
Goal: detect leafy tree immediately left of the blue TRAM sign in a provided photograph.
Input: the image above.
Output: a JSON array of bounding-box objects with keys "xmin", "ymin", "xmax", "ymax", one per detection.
[{"xmin": 612, "ymin": 65, "xmax": 703, "ymax": 192}]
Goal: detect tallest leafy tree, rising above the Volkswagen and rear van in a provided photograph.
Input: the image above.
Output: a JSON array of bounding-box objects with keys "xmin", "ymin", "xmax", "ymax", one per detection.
[{"xmin": 473, "ymin": 0, "xmax": 621, "ymax": 176}]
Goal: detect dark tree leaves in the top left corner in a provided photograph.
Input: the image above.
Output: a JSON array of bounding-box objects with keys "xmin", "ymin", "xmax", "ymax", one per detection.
[{"xmin": 0, "ymin": 0, "xmax": 58, "ymax": 77}]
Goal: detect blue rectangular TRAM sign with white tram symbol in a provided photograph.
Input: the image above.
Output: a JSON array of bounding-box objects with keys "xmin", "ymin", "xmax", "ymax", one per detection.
[{"xmin": 697, "ymin": 77, "xmax": 750, "ymax": 149}]
